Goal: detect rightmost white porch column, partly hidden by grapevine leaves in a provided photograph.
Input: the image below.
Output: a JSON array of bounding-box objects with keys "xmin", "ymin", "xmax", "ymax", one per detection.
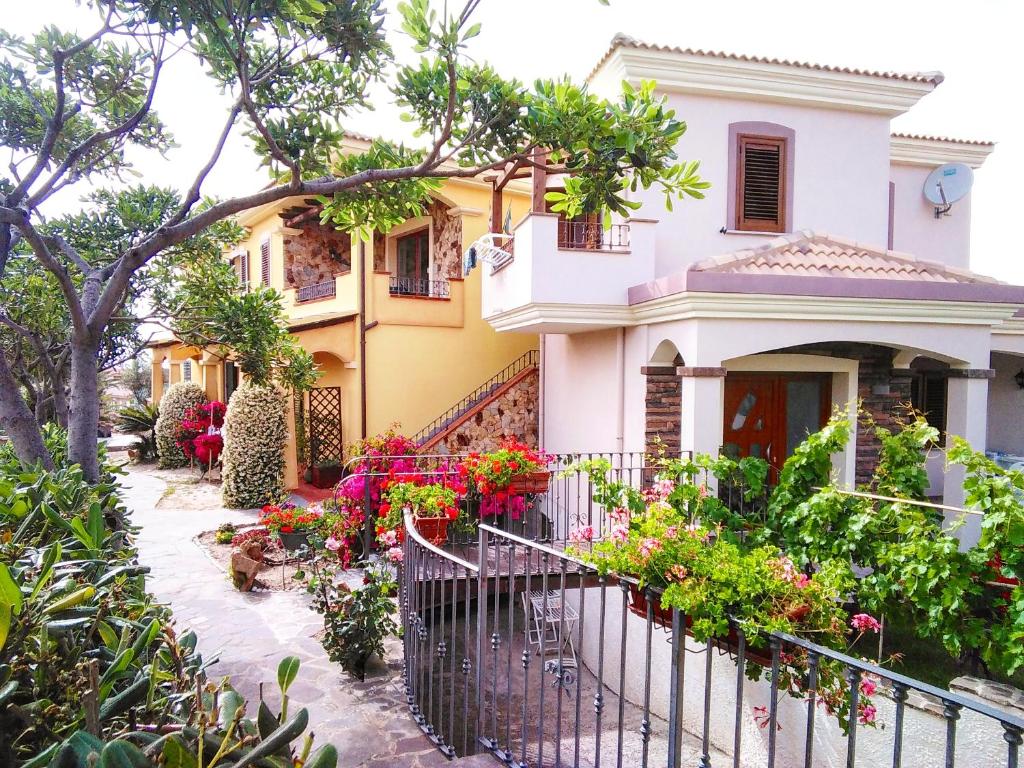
[{"xmin": 942, "ymin": 369, "xmax": 991, "ymax": 546}]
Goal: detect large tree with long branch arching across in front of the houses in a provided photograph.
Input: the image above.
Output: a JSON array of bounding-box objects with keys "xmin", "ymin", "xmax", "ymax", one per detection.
[{"xmin": 0, "ymin": 0, "xmax": 706, "ymax": 480}]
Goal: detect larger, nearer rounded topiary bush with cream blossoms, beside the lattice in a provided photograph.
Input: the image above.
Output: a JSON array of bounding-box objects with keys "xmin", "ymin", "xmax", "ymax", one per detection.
[{"xmin": 221, "ymin": 383, "xmax": 288, "ymax": 509}]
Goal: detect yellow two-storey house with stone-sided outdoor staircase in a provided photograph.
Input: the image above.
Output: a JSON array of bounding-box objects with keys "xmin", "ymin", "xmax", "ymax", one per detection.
[{"xmin": 151, "ymin": 136, "xmax": 538, "ymax": 487}]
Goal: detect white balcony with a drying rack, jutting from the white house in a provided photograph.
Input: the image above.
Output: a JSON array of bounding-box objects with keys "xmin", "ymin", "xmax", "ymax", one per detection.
[{"xmin": 477, "ymin": 213, "xmax": 656, "ymax": 333}]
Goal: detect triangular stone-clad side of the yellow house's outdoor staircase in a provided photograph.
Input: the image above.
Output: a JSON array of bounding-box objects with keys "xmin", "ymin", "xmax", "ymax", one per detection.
[{"xmin": 430, "ymin": 371, "xmax": 540, "ymax": 454}]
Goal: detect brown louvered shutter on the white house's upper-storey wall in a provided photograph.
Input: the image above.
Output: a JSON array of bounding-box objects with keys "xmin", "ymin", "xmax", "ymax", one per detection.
[{"xmin": 736, "ymin": 134, "xmax": 785, "ymax": 232}]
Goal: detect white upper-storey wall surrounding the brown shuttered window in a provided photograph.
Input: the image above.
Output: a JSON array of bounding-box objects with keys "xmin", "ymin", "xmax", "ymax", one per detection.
[{"xmin": 618, "ymin": 94, "xmax": 889, "ymax": 276}]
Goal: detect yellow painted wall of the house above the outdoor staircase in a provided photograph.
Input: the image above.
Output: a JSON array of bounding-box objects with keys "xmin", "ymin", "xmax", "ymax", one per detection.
[{"xmin": 154, "ymin": 180, "xmax": 538, "ymax": 487}]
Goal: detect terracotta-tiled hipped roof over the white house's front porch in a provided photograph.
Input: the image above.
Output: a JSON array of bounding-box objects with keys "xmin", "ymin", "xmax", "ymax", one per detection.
[{"xmin": 690, "ymin": 230, "xmax": 999, "ymax": 285}]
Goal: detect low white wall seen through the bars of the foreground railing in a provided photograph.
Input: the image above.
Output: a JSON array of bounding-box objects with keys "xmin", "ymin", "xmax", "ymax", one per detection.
[{"xmin": 568, "ymin": 586, "xmax": 1006, "ymax": 768}]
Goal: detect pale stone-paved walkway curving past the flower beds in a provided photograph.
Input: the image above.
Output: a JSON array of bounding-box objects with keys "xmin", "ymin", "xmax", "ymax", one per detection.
[{"xmin": 124, "ymin": 468, "xmax": 451, "ymax": 768}]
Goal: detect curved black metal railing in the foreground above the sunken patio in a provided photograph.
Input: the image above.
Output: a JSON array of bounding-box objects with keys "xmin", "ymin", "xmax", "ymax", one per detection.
[{"xmin": 378, "ymin": 462, "xmax": 1024, "ymax": 768}]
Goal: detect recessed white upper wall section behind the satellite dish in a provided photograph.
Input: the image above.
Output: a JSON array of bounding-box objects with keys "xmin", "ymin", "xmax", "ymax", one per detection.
[{"xmin": 883, "ymin": 164, "xmax": 971, "ymax": 269}]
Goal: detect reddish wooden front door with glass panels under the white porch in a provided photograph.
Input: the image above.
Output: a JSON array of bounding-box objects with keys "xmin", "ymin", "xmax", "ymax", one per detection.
[{"xmin": 722, "ymin": 374, "xmax": 831, "ymax": 482}]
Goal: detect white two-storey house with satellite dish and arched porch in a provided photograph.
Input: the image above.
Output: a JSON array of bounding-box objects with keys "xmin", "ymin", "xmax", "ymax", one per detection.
[{"xmin": 483, "ymin": 36, "xmax": 1024, "ymax": 528}]
